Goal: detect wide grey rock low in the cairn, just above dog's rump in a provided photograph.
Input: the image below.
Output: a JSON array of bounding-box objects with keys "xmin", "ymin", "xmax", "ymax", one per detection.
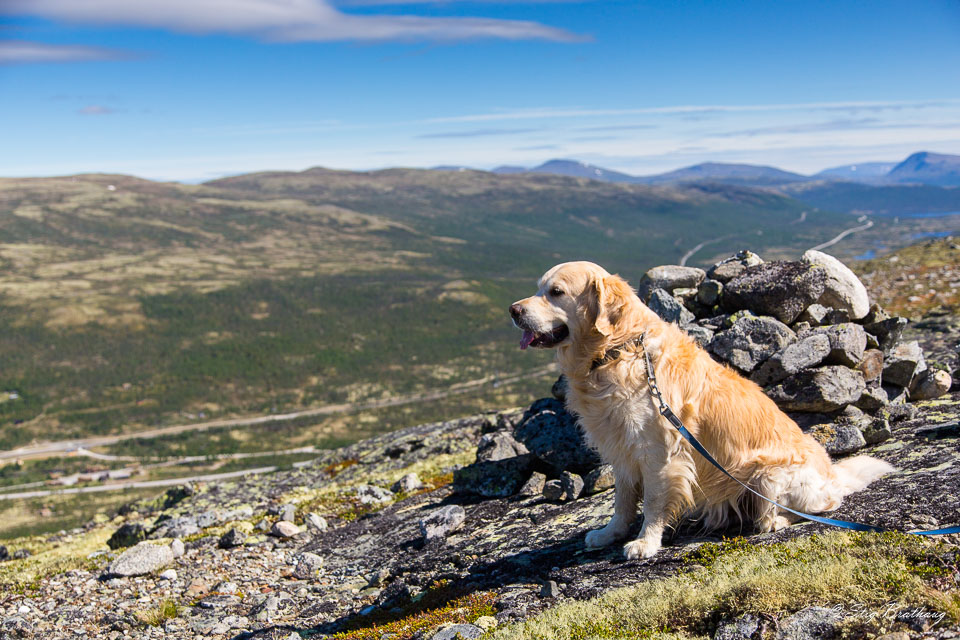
[{"xmin": 767, "ymin": 366, "xmax": 866, "ymax": 412}]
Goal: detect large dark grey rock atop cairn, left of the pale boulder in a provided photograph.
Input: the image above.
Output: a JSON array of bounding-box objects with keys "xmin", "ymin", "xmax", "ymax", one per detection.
[{"xmin": 723, "ymin": 261, "xmax": 826, "ymax": 324}]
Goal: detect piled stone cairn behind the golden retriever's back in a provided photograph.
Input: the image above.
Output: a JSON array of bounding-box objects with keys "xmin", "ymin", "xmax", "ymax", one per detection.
[{"xmin": 638, "ymin": 250, "xmax": 951, "ymax": 454}]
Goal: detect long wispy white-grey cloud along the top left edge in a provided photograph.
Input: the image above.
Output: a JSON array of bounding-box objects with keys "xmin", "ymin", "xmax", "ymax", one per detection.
[{"xmin": 0, "ymin": 0, "xmax": 588, "ymax": 42}]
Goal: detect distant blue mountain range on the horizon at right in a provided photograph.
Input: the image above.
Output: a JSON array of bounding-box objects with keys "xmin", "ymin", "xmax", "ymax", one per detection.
[{"xmin": 462, "ymin": 151, "xmax": 960, "ymax": 187}]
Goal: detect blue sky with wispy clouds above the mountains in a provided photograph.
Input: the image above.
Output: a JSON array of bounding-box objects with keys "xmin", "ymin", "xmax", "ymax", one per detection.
[{"xmin": 0, "ymin": 0, "xmax": 960, "ymax": 181}]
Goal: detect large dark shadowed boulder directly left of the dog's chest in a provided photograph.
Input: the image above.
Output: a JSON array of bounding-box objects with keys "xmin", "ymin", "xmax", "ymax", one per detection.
[{"xmin": 508, "ymin": 398, "xmax": 601, "ymax": 476}]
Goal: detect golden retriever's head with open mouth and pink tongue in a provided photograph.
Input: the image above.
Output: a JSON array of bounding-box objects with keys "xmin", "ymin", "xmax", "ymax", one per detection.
[{"xmin": 510, "ymin": 262, "xmax": 634, "ymax": 349}]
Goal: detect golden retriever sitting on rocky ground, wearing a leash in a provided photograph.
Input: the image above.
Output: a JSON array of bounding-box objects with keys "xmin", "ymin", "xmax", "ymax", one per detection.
[{"xmin": 510, "ymin": 262, "xmax": 893, "ymax": 559}]
